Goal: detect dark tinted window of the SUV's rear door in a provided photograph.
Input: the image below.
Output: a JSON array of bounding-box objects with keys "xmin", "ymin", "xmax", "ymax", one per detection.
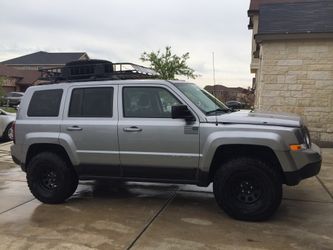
[{"xmin": 68, "ymin": 87, "xmax": 113, "ymax": 117}]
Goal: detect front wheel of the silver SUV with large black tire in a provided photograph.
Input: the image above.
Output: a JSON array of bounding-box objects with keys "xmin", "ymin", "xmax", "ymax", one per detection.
[{"xmin": 213, "ymin": 158, "xmax": 282, "ymax": 221}]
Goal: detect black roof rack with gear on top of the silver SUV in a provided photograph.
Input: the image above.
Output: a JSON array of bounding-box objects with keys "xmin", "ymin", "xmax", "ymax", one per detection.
[{"xmin": 39, "ymin": 59, "xmax": 159, "ymax": 84}]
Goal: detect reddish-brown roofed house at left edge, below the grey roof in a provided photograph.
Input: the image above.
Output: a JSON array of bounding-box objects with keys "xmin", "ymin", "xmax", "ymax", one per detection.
[{"xmin": 0, "ymin": 64, "xmax": 40, "ymax": 93}]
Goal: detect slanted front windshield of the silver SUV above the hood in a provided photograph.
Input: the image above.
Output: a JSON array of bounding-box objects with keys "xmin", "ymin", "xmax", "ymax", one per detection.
[{"xmin": 174, "ymin": 83, "xmax": 230, "ymax": 115}]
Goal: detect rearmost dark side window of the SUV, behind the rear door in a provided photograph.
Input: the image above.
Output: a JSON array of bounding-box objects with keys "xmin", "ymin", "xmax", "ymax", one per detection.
[{"xmin": 28, "ymin": 89, "xmax": 63, "ymax": 117}]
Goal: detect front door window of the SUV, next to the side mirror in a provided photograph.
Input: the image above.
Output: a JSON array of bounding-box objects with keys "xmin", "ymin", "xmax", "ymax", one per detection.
[{"xmin": 123, "ymin": 87, "xmax": 180, "ymax": 118}]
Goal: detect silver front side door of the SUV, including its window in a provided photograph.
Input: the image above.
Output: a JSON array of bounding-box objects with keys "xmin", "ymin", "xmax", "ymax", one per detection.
[{"xmin": 118, "ymin": 85, "xmax": 199, "ymax": 180}]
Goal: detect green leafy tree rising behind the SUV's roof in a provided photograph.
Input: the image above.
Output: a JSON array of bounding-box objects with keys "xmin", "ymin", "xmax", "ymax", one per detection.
[{"xmin": 140, "ymin": 46, "xmax": 197, "ymax": 80}]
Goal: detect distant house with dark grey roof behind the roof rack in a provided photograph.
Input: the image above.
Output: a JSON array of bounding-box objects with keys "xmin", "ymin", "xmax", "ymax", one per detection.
[{"xmin": 1, "ymin": 51, "xmax": 89, "ymax": 70}]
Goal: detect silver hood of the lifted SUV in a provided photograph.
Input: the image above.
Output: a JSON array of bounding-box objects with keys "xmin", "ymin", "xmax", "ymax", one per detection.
[{"xmin": 207, "ymin": 110, "xmax": 303, "ymax": 127}]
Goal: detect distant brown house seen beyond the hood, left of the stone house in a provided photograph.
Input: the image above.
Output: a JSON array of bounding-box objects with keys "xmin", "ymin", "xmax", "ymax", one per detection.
[{"xmin": 205, "ymin": 85, "xmax": 254, "ymax": 106}]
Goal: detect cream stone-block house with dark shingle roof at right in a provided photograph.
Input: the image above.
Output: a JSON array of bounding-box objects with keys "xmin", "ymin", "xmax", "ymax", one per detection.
[{"xmin": 248, "ymin": 0, "xmax": 333, "ymax": 145}]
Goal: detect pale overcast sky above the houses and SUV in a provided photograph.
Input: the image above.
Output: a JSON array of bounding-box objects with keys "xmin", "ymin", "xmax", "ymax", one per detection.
[{"xmin": 0, "ymin": 0, "xmax": 252, "ymax": 88}]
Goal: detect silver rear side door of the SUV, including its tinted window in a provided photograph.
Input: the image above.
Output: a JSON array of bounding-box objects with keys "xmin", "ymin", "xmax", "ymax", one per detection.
[{"xmin": 61, "ymin": 85, "xmax": 121, "ymax": 176}]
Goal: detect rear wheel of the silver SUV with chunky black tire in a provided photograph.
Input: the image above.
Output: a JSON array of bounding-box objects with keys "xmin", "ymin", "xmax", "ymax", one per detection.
[{"xmin": 27, "ymin": 152, "xmax": 78, "ymax": 204}]
